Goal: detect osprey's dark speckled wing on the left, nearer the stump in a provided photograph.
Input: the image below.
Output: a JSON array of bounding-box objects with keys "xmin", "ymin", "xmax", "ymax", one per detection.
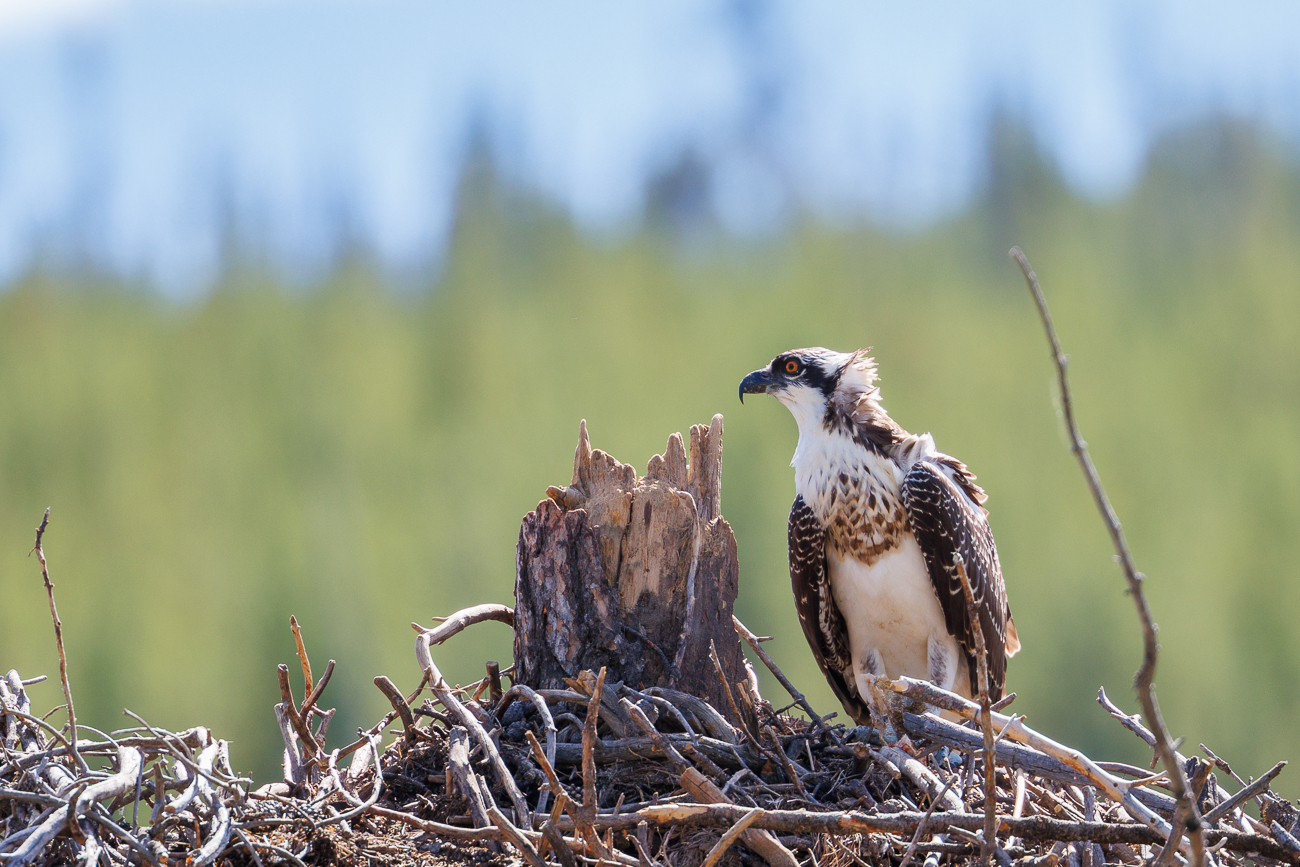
[{"xmin": 789, "ymin": 497, "xmax": 871, "ymax": 725}]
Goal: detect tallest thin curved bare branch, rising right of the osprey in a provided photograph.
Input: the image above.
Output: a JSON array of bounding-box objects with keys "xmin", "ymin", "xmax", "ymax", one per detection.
[{"xmin": 1010, "ymin": 247, "xmax": 1205, "ymax": 867}]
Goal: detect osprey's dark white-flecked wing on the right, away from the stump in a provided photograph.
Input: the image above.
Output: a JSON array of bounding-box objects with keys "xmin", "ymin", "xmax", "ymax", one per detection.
[{"xmin": 902, "ymin": 460, "xmax": 1011, "ymax": 701}]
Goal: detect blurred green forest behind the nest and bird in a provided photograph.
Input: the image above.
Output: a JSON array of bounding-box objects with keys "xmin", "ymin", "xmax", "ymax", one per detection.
[{"xmin": 0, "ymin": 123, "xmax": 1300, "ymax": 796}]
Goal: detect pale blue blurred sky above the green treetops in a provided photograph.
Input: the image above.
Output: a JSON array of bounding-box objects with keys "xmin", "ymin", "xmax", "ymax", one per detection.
[{"xmin": 0, "ymin": 0, "xmax": 1300, "ymax": 294}]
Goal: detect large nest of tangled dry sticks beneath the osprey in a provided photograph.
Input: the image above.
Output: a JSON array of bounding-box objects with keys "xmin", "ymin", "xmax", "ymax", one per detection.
[{"xmin": 0, "ymin": 606, "xmax": 1300, "ymax": 867}]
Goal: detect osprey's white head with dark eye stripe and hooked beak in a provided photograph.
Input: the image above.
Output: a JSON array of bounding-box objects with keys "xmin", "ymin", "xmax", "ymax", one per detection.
[{"xmin": 740, "ymin": 347, "xmax": 880, "ymax": 432}]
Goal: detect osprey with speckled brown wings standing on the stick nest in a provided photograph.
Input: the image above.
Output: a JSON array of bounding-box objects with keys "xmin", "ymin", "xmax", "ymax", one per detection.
[{"xmin": 740, "ymin": 347, "xmax": 1021, "ymax": 725}]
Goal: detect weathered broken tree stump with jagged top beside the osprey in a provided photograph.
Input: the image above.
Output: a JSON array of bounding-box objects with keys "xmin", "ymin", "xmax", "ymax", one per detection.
[{"xmin": 515, "ymin": 415, "xmax": 749, "ymax": 721}]
